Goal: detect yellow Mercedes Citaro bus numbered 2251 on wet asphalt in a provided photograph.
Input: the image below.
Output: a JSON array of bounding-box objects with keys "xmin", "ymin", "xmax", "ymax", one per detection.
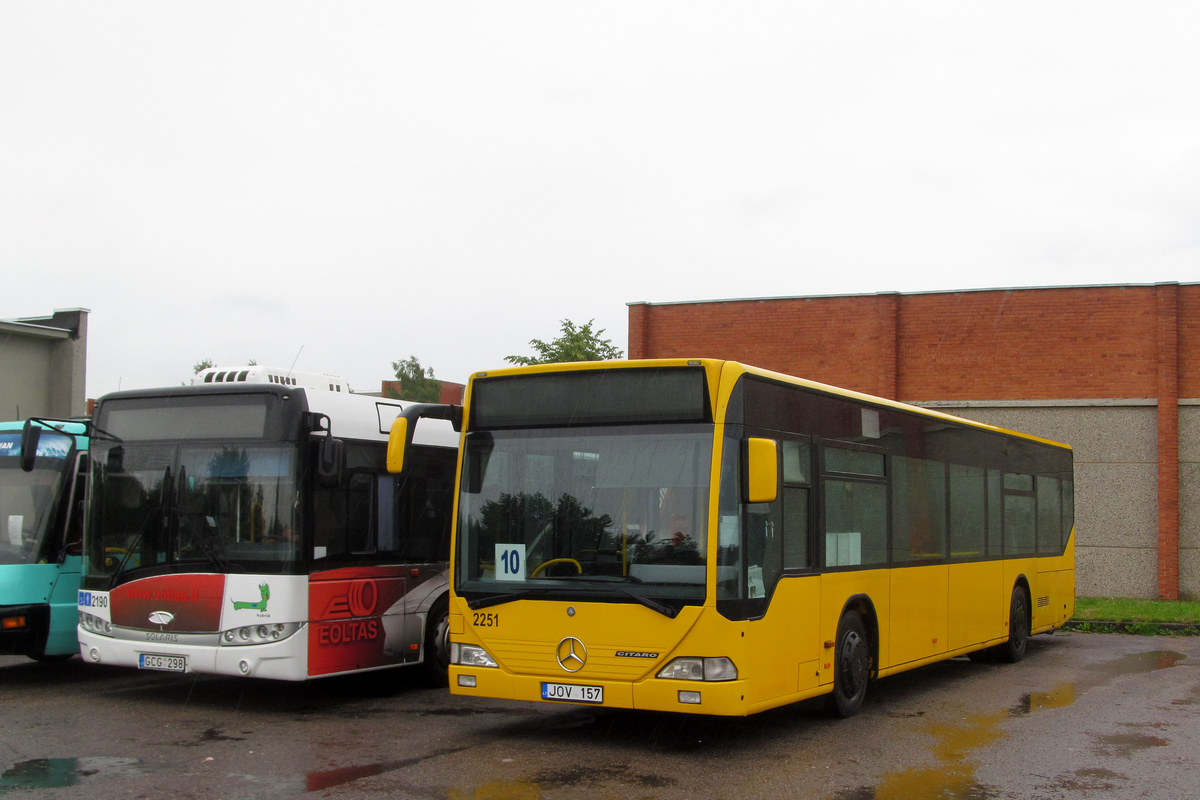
[{"xmin": 389, "ymin": 359, "xmax": 1075, "ymax": 716}]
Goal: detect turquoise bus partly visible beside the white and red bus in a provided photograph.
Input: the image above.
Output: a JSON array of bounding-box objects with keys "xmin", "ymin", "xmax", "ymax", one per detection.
[{"xmin": 0, "ymin": 419, "xmax": 88, "ymax": 661}]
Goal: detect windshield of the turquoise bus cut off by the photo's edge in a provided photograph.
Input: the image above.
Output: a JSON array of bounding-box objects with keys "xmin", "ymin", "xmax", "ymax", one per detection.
[{"xmin": 0, "ymin": 431, "xmax": 74, "ymax": 564}]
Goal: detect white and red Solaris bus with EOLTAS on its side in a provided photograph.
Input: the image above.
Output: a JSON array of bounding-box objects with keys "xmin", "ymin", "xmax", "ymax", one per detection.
[{"xmin": 79, "ymin": 366, "xmax": 458, "ymax": 684}]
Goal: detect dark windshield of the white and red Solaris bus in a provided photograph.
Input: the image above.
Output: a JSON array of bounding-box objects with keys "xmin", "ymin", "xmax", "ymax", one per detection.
[{"xmin": 88, "ymin": 441, "xmax": 300, "ymax": 585}]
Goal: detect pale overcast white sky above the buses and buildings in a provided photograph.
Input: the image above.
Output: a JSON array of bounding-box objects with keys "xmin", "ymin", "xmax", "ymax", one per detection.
[{"xmin": 0, "ymin": 0, "xmax": 1200, "ymax": 397}]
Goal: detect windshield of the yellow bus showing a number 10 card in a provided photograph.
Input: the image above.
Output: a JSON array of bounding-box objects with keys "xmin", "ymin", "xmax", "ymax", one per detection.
[{"xmin": 456, "ymin": 423, "xmax": 713, "ymax": 604}]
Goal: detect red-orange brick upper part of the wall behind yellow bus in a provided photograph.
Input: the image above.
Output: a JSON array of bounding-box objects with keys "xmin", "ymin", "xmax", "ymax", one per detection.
[{"xmin": 629, "ymin": 284, "xmax": 1185, "ymax": 399}]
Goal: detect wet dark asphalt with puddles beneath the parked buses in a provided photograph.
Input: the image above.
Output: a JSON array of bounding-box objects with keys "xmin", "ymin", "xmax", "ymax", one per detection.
[{"xmin": 0, "ymin": 633, "xmax": 1200, "ymax": 800}]
